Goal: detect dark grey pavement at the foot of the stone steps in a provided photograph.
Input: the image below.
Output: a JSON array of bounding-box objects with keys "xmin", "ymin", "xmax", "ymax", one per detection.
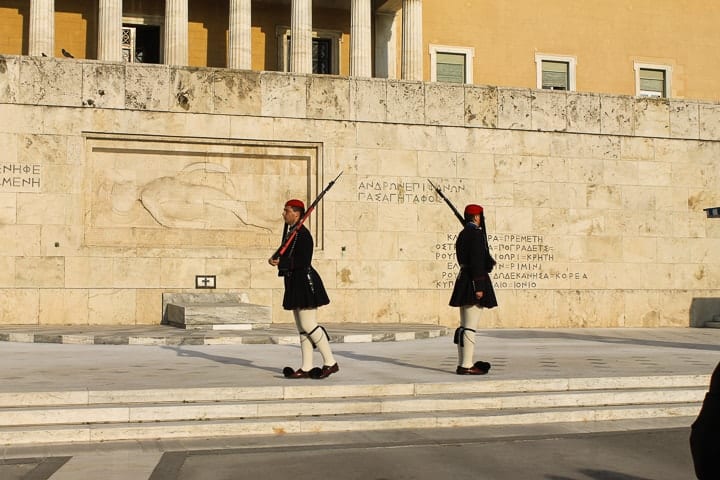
[{"xmin": 0, "ymin": 418, "xmax": 694, "ymax": 480}]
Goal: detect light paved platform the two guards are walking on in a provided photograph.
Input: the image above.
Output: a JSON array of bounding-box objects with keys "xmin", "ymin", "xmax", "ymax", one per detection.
[{"xmin": 0, "ymin": 326, "xmax": 720, "ymax": 392}]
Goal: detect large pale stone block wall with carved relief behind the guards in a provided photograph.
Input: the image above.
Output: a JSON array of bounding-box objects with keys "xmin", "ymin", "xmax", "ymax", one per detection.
[{"xmin": 0, "ymin": 56, "xmax": 720, "ymax": 328}]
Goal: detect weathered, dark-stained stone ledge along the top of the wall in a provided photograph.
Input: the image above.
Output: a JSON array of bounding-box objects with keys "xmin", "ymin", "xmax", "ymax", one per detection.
[{"xmin": 0, "ymin": 55, "xmax": 720, "ymax": 140}]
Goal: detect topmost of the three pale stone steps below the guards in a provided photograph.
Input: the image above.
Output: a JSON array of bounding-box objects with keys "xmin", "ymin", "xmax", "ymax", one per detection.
[{"xmin": 0, "ymin": 375, "xmax": 710, "ymax": 408}]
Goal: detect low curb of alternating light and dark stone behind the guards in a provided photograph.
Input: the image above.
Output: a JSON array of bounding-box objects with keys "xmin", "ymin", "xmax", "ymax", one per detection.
[{"xmin": 0, "ymin": 327, "xmax": 450, "ymax": 346}]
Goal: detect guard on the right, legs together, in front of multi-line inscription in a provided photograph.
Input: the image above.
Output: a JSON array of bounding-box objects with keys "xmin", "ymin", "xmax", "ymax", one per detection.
[{"xmin": 450, "ymin": 204, "xmax": 497, "ymax": 375}]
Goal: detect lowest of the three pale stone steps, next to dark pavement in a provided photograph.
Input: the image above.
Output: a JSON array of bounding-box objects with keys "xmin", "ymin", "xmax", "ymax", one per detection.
[{"xmin": 0, "ymin": 404, "xmax": 700, "ymax": 446}]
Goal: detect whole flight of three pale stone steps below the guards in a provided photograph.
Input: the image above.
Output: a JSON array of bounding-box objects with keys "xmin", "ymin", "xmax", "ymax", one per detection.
[{"xmin": 0, "ymin": 375, "xmax": 709, "ymax": 445}]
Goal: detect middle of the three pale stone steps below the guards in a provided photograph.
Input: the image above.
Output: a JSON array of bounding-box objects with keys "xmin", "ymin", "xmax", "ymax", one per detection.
[{"xmin": 0, "ymin": 388, "xmax": 705, "ymax": 427}]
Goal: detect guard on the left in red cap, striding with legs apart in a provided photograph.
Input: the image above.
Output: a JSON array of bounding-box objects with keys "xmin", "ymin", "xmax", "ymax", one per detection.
[{"xmin": 268, "ymin": 199, "xmax": 340, "ymax": 379}]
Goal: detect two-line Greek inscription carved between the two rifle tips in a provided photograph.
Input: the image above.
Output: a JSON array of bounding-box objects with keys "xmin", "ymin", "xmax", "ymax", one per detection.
[{"xmin": 357, "ymin": 177, "xmax": 465, "ymax": 204}]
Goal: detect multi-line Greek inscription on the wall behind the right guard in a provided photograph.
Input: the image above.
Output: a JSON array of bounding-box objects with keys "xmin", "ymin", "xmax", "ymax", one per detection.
[{"xmin": 435, "ymin": 233, "xmax": 588, "ymax": 289}]
